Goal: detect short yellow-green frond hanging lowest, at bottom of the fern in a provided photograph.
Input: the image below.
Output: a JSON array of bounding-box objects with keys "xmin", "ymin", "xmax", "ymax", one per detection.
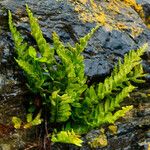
[{"xmin": 51, "ymin": 130, "xmax": 83, "ymax": 146}]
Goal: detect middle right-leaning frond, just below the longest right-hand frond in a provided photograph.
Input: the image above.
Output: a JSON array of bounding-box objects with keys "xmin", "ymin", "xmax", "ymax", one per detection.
[{"xmin": 81, "ymin": 85, "xmax": 135, "ymax": 127}]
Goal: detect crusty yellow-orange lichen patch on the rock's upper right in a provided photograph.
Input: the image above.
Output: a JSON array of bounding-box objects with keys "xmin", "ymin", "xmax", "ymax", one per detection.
[{"xmin": 69, "ymin": 0, "xmax": 147, "ymax": 37}]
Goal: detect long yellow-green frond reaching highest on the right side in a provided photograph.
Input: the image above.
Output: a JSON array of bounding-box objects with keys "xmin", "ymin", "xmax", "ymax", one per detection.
[{"xmin": 98, "ymin": 44, "xmax": 148, "ymax": 100}]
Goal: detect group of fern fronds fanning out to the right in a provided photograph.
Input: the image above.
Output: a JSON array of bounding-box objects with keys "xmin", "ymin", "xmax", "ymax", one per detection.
[{"xmin": 72, "ymin": 45, "xmax": 146, "ymax": 131}]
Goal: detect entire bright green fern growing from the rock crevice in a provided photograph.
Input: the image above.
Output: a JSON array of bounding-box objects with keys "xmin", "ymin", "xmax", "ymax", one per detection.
[{"xmin": 9, "ymin": 5, "xmax": 147, "ymax": 146}]
